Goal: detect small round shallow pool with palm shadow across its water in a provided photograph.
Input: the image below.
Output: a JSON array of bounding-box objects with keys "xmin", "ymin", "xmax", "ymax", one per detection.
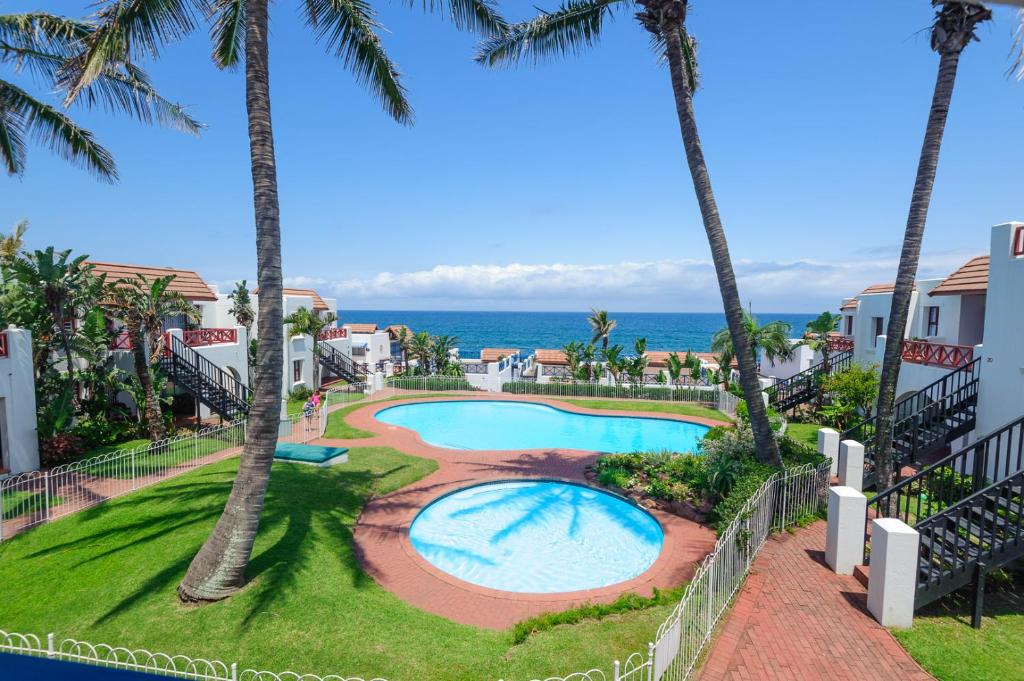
[{"xmin": 410, "ymin": 480, "xmax": 665, "ymax": 593}]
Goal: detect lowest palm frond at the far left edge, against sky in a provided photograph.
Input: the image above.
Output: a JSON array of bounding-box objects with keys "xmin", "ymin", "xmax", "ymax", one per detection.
[{"xmin": 0, "ymin": 81, "xmax": 118, "ymax": 181}]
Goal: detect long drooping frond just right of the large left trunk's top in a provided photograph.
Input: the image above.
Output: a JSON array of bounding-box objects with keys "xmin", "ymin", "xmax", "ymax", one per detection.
[{"xmin": 305, "ymin": 0, "xmax": 413, "ymax": 124}]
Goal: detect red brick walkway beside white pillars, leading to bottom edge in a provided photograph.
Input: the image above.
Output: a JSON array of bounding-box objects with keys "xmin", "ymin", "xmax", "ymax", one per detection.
[{"xmin": 697, "ymin": 521, "xmax": 932, "ymax": 681}]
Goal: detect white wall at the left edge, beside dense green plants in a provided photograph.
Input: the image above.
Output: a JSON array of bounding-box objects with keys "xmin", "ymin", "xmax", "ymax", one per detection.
[{"xmin": 0, "ymin": 327, "xmax": 39, "ymax": 473}]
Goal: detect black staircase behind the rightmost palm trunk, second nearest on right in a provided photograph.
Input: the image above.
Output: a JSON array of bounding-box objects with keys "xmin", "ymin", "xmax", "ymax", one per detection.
[{"xmin": 840, "ymin": 359, "xmax": 981, "ymax": 488}]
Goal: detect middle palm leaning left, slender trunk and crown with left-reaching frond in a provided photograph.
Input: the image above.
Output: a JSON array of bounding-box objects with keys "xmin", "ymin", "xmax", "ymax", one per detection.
[{"xmin": 476, "ymin": 0, "xmax": 781, "ymax": 466}]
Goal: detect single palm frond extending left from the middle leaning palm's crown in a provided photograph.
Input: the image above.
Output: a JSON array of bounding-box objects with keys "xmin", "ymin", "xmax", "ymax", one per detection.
[{"xmin": 474, "ymin": 0, "xmax": 625, "ymax": 67}]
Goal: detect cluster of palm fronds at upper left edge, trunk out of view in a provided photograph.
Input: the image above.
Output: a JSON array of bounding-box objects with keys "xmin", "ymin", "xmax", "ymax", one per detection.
[{"xmin": 0, "ymin": 12, "xmax": 203, "ymax": 181}]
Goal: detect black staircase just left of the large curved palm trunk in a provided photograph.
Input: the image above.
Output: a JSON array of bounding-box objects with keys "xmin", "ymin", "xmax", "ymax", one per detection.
[{"xmin": 160, "ymin": 335, "xmax": 250, "ymax": 421}]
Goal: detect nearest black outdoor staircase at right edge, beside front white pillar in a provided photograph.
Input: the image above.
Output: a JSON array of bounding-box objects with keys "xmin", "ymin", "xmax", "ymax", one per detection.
[{"xmin": 865, "ymin": 417, "xmax": 1024, "ymax": 627}]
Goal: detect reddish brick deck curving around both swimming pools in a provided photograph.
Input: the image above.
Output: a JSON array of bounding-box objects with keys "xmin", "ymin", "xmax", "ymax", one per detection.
[{"xmin": 331, "ymin": 394, "xmax": 721, "ymax": 629}]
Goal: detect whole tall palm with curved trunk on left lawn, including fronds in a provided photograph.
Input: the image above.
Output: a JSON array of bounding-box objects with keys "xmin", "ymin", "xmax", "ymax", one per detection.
[{"xmin": 68, "ymin": 0, "xmax": 506, "ymax": 602}]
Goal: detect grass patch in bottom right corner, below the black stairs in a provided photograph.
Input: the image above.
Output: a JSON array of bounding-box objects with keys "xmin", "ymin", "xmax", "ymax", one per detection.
[{"xmin": 893, "ymin": 581, "xmax": 1024, "ymax": 681}]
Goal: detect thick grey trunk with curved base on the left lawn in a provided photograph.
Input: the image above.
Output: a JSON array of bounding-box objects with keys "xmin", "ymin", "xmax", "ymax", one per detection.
[{"xmin": 178, "ymin": 0, "xmax": 284, "ymax": 601}]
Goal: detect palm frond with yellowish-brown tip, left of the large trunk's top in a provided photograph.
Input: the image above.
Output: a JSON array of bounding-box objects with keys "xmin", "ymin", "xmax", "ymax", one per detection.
[{"xmin": 66, "ymin": 0, "xmax": 207, "ymax": 103}]
